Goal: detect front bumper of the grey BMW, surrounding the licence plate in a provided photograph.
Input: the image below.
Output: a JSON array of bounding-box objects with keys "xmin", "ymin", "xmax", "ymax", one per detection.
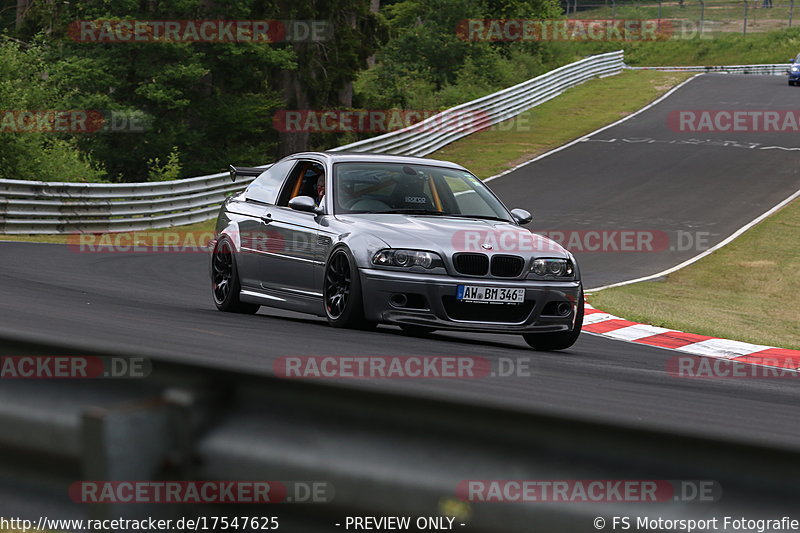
[{"xmin": 359, "ymin": 269, "xmax": 583, "ymax": 333}]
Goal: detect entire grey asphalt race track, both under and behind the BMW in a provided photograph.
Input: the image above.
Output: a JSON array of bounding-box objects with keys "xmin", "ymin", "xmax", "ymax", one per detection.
[{"xmin": 0, "ymin": 75, "xmax": 800, "ymax": 448}]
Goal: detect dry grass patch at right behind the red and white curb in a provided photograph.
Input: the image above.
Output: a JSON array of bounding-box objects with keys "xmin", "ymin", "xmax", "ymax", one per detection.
[{"xmin": 589, "ymin": 200, "xmax": 800, "ymax": 349}]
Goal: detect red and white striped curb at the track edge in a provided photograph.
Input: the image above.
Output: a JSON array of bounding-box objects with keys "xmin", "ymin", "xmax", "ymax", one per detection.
[{"xmin": 583, "ymin": 303, "xmax": 800, "ymax": 370}]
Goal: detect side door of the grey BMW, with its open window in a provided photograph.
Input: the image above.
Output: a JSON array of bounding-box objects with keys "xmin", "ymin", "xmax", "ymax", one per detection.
[{"xmin": 252, "ymin": 159, "xmax": 324, "ymax": 299}]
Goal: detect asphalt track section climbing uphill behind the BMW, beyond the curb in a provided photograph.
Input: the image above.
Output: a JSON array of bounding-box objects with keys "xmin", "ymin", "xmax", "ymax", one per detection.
[{"xmin": 490, "ymin": 74, "xmax": 800, "ymax": 288}]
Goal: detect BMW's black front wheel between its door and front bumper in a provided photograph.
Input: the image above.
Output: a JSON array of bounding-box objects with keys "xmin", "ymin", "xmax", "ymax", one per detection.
[{"xmin": 322, "ymin": 246, "xmax": 375, "ymax": 329}]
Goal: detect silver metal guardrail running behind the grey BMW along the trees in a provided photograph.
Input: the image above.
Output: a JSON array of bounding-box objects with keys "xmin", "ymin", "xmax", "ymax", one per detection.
[{"xmin": 0, "ymin": 51, "xmax": 623, "ymax": 234}]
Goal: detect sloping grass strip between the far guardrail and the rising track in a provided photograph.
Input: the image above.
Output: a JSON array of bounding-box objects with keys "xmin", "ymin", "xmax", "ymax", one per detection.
[{"xmin": 429, "ymin": 71, "xmax": 690, "ymax": 178}]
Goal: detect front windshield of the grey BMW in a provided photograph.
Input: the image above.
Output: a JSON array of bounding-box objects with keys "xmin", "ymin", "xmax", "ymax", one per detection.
[{"xmin": 333, "ymin": 163, "xmax": 512, "ymax": 221}]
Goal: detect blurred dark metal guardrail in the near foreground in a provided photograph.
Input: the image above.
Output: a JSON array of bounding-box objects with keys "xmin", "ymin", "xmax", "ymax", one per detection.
[{"xmin": 0, "ymin": 332, "xmax": 800, "ymax": 533}]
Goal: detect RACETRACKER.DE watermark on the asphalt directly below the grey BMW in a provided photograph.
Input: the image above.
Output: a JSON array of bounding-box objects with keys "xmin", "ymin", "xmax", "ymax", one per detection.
[{"xmin": 273, "ymin": 355, "xmax": 533, "ymax": 379}]
